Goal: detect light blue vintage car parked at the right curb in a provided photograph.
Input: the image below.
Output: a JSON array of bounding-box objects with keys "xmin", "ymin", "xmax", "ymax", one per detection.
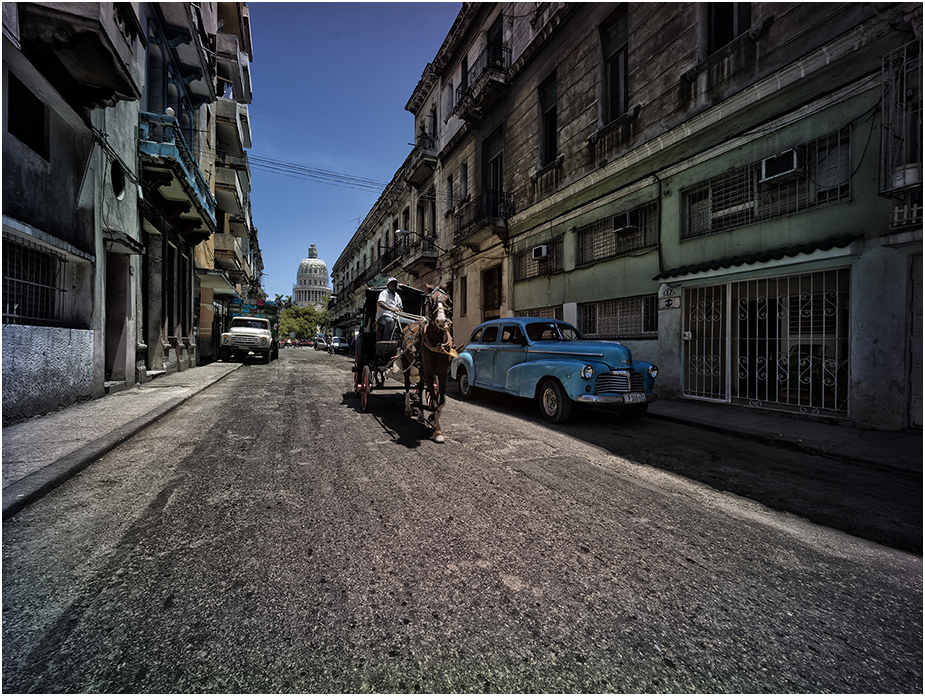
[{"xmin": 450, "ymin": 317, "xmax": 658, "ymax": 423}]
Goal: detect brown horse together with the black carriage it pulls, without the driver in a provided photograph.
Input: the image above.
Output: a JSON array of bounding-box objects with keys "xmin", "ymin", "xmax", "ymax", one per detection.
[{"xmin": 353, "ymin": 285, "xmax": 455, "ymax": 442}]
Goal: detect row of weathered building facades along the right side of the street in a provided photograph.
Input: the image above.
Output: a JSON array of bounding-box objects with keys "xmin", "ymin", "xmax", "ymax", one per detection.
[{"xmin": 335, "ymin": 3, "xmax": 922, "ymax": 428}]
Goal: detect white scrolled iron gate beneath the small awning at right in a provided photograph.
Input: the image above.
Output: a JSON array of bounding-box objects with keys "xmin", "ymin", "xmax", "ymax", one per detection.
[{"xmin": 683, "ymin": 269, "xmax": 849, "ymax": 415}]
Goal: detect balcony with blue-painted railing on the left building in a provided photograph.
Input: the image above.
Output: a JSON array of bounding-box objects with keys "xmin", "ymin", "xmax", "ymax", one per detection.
[{"xmin": 138, "ymin": 112, "xmax": 216, "ymax": 239}]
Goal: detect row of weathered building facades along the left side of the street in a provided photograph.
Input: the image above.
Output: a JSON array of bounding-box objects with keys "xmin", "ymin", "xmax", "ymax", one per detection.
[{"xmin": 3, "ymin": 3, "xmax": 260, "ymax": 423}]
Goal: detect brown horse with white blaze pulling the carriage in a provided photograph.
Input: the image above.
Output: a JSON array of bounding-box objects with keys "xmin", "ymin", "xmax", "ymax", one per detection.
[{"xmin": 401, "ymin": 285, "xmax": 456, "ymax": 442}]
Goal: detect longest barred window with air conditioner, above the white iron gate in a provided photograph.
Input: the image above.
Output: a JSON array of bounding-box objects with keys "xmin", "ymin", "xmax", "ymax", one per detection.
[{"xmin": 681, "ymin": 126, "xmax": 851, "ymax": 239}]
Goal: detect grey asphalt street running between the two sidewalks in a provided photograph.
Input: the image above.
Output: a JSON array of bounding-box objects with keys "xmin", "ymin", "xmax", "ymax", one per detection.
[{"xmin": 3, "ymin": 349, "xmax": 922, "ymax": 693}]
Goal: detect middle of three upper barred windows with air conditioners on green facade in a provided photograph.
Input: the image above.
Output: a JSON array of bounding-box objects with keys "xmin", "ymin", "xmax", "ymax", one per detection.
[{"xmin": 576, "ymin": 202, "xmax": 658, "ymax": 266}]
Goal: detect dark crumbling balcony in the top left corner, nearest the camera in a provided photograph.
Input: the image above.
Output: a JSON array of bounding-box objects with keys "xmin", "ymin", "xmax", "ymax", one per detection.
[{"xmin": 12, "ymin": 2, "xmax": 144, "ymax": 108}]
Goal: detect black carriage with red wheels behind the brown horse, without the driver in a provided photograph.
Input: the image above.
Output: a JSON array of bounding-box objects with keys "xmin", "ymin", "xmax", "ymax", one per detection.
[{"xmin": 353, "ymin": 285, "xmax": 425, "ymax": 411}]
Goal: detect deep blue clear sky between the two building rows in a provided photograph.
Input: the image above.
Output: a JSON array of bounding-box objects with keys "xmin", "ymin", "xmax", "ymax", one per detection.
[{"xmin": 248, "ymin": 1, "xmax": 462, "ymax": 300}]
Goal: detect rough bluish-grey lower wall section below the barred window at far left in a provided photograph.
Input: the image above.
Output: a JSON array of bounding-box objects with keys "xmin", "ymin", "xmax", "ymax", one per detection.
[{"xmin": 3, "ymin": 326, "xmax": 102, "ymax": 425}]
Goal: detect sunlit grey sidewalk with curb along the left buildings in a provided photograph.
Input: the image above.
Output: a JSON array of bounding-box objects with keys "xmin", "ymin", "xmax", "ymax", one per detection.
[{"xmin": 3, "ymin": 362, "xmax": 242, "ymax": 519}]
